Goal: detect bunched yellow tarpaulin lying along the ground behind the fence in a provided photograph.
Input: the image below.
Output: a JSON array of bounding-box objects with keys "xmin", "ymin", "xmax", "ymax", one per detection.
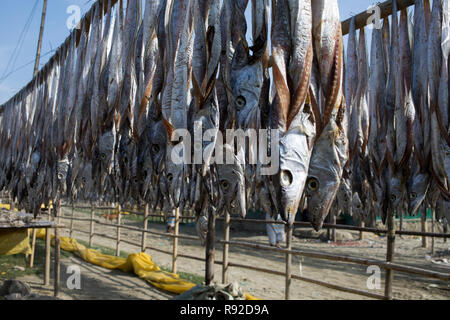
[{"xmin": 36, "ymin": 229, "xmax": 257, "ymax": 300}]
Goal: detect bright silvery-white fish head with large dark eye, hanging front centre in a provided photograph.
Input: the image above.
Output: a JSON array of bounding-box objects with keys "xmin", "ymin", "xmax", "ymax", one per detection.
[{"xmin": 277, "ymin": 129, "xmax": 310, "ymax": 222}]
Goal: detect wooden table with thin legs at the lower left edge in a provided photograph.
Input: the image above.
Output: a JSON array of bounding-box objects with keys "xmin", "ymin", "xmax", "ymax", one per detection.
[{"xmin": 0, "ymin": 212, "xmax": 65, "ymax": 297}]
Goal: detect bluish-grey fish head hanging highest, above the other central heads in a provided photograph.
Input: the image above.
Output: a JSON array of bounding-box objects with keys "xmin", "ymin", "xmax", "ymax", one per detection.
[{"xmin": 230, "ymin": 41, "xmax": 264, "ymax": 128}]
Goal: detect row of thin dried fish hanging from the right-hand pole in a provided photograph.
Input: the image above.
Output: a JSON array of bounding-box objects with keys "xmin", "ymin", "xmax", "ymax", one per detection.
[{"xmin": 333, "ymin": 0, "xmax": 450, "ymax": 230}]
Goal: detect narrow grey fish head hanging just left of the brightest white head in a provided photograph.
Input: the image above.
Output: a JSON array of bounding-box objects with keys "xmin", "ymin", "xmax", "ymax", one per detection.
[{"xmin": 217, "ymin": 144, "xmax": 247, "ymax": 218}]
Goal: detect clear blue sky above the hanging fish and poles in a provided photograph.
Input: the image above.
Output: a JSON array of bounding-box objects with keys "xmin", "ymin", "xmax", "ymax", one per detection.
[{"xmin": 0, "ymin": 0, "xmax": 384, "ymax": 104}]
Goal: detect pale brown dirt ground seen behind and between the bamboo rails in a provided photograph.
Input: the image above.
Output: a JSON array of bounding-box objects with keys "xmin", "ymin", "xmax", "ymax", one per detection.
[{"xmin": 10, "ymin": 209, "xmax": 450, "ymax": 300}]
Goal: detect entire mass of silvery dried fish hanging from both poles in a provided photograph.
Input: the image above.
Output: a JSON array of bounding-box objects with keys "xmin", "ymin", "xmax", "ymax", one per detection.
[{"xmin": 0, "ymin": 0, "xmax": 450, "ymax": 242}]
